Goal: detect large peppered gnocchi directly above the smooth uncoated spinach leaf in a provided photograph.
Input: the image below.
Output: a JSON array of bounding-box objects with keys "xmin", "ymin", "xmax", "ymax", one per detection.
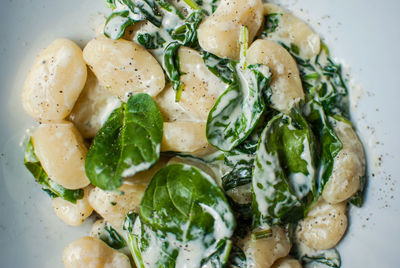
[{"xmin": 83, "ymin": 36, "xmax": 165, "ymax": 101}]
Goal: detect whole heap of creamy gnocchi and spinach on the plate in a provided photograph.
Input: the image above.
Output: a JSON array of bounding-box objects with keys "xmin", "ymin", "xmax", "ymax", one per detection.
[{"xmin": 22, "ymin": 0, "xmax": 366, "ymax": 268}]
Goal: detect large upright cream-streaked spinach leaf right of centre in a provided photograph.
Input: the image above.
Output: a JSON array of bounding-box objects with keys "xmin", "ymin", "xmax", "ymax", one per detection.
[{"xmin": 252, "ymin": 108, "xmax": 315, "ymax": 227}]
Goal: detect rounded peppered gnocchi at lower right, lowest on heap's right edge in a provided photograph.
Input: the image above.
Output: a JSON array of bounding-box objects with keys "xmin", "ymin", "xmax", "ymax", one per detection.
[{"xmin": 296, "ymin": 199, "xmax": 347, "ymax": 250}]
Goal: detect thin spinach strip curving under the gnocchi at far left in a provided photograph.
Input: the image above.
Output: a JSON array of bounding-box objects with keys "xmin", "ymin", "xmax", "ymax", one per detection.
[{"xmin": 24, "ymin": 138, "xmax": 83, "ymax": 204}]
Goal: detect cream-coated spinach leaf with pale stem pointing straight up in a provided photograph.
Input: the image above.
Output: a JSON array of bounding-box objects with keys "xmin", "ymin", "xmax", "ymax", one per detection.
[{"xmin": 206, "ymin": 27, "xmax": 271, "ymax": 151}]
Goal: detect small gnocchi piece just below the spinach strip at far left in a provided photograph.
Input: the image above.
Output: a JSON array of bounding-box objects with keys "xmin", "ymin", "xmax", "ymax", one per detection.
[{"xmin": 52, "ymin": 186, "xmax": 93, "ymax": 226}]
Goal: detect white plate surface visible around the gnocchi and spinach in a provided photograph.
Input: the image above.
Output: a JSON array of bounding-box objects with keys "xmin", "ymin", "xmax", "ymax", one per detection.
[{"xmin": 0, "ymin": 0, "xmax": 400, "ymax": 268}]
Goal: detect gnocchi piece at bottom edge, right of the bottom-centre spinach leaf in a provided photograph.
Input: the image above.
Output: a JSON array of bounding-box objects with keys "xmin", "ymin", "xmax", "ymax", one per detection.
[{"xmin": 244, "ymin": 226, "xmax": 291, "ymax": 268}]
